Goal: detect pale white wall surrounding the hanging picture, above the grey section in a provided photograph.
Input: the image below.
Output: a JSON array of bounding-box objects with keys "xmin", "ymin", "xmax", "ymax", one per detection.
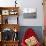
[{"xmin": 17, "ymin": 0, "xmax": 43, "ymax": 26}]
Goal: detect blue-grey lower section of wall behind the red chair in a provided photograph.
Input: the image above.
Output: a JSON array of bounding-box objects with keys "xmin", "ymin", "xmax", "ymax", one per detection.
[{"xmin": 19, "ymin": 26, "xmax": 43, "ymax": 43}]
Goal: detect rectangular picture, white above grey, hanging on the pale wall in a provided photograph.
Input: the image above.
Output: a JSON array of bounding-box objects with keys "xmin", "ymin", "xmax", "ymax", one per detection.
[{"xmin": 23, "ymin": 8, "xmax": 37, "ymax": 19}]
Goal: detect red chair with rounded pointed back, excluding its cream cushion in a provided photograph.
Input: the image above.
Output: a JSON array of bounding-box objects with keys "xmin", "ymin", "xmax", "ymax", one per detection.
[{"xmin": 21, "ymin": 28, "xmax": 41, "ymax": 46}]
